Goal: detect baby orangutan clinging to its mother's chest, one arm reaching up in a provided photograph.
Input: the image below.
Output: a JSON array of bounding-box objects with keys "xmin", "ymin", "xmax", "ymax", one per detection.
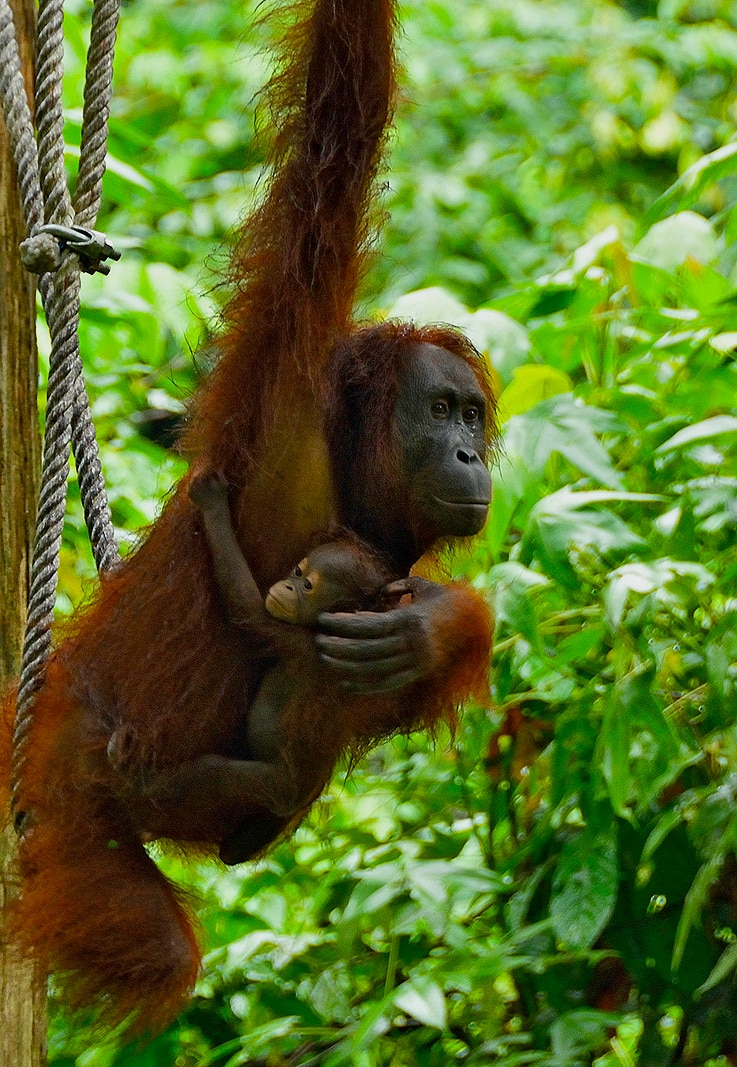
[{"xmin": 108, "ymin": 472, "xmax": 401, "ymax": 863}]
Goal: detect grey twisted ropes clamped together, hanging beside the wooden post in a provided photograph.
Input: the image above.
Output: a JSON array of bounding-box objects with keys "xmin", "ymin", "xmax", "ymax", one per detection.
[{"xmin": 0, "ymin": 0, "xmax": 119, "ymax": 806}]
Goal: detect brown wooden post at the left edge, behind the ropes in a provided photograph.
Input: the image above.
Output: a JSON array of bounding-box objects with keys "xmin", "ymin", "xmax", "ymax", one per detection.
[{"xmin": 0, "ymin": 0, "xmax": 46, "ymax": 1067}]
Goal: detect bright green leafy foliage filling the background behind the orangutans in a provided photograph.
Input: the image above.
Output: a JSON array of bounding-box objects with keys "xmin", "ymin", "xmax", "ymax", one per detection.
[{"xmin": 38, "ymin": 0, "xmax": 737, "ymax": 1067}]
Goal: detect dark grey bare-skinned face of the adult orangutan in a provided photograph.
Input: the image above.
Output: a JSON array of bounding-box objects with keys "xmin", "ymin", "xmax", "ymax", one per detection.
[{"xmin": 395, "ymin": 345, "xmax": 492, "ymax": 550}]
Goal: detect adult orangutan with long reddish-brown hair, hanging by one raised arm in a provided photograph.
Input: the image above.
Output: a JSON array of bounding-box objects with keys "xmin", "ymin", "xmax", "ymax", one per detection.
[{"xmin": 4, "ymin": 0, "xmax": 494, "ymax": 1031}]
